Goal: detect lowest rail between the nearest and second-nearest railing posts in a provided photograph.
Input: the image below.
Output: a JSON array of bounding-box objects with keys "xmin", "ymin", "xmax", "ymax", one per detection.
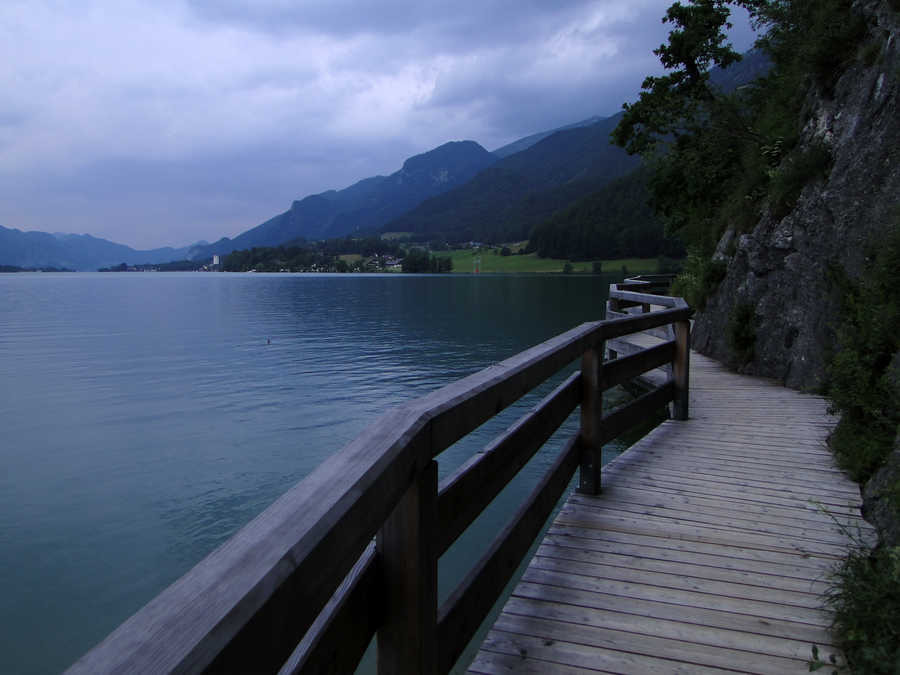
[{"xmin": 438, "ymin": 436, "xmax": 579, "ymax": 673}]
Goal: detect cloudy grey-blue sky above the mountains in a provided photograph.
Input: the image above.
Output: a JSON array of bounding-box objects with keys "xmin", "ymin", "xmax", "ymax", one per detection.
[{"xmin": 0, "ymin": 0, "xmax": 752, "ymax": 248}]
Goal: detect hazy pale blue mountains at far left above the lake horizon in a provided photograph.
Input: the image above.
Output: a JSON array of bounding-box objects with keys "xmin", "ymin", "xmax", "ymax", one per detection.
[{"xmin": 0, "ymin": 226, "xmax": 190, "ymax": 270}]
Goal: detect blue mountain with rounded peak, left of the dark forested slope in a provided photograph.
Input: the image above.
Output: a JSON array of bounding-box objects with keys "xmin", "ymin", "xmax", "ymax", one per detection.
[{"xmin": 195, "ymin": 141, "xmax": 497, "ymax": 256}]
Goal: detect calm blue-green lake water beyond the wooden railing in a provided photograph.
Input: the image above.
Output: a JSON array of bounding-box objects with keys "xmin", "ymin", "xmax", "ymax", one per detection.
[{"xmin": 0, "ymin": 273, "xmax": 628, "ymax": 673}]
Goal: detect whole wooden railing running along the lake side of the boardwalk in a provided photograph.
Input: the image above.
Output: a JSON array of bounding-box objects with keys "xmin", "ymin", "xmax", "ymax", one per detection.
[{"xmin": 70, "ymin": 278, "xmax": 690, "ymax": 674}]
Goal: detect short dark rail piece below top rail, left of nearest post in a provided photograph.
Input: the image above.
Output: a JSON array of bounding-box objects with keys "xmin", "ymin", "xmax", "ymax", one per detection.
[{"xmin": 278, "ymin": 544, "xmax": 385, "ymax": 675}]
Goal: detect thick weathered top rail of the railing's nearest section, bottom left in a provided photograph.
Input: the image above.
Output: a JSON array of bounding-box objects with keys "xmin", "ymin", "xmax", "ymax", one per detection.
[{"xmin": 70, "ymin": 407, "xmax": 428, "ymax": 673}]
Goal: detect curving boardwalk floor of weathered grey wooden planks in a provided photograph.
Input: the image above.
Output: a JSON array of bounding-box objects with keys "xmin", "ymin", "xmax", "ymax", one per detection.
[{"xmin": 469, "ymin": 346, "xmax": 871, "ymax": 673}]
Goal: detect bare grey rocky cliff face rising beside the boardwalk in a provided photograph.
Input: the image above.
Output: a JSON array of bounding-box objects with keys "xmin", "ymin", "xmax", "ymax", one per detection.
[{"xmin": 693, "ymin": 0, "xmax": 900, "ymax": 389}]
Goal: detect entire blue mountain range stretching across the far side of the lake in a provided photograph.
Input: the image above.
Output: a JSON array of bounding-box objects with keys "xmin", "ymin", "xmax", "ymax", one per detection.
[{"xmin": 0, "ymin": 50, "xmax": 769, "ymax": 270}]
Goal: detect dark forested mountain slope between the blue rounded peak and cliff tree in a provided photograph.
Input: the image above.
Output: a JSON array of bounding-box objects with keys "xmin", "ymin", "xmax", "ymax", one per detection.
[{"xmin": 383, "ymin": 113, "xmax": 640, "ymax": 241}]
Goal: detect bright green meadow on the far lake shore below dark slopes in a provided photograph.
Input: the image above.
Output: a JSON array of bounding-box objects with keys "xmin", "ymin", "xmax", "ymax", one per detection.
[{"xmin": 444, "ymin": 248, "xmax": 658, "ymax": 275}]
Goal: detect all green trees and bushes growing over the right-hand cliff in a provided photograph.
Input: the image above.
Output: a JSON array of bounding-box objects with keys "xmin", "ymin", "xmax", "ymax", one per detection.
[{"xmin": 613, "ymin": 0, "xmax": 900, "ymax": 673}]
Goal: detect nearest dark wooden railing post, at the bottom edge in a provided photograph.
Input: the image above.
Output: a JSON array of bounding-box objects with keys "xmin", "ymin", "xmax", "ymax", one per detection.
[{"xmin": 377, "ymin": 461, "xmax": 437, "ymax": 675}]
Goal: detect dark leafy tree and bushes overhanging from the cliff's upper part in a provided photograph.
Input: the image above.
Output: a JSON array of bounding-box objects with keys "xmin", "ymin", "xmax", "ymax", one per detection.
[{"xmin": 613, "ymin": 0, "xmax": 865, "ymax": 304}]
